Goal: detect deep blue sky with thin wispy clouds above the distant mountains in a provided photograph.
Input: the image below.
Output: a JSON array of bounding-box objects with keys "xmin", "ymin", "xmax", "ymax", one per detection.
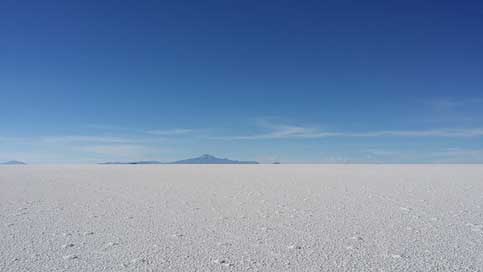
[{"xmin": 0, "ymin": 0, "xmax": 483, "ymax": 163}]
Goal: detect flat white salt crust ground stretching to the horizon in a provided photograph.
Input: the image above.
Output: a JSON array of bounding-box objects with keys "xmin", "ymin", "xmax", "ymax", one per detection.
[{"xmin": 0, "ymin": 165, "xmax": 483, "ymax": 272}]
